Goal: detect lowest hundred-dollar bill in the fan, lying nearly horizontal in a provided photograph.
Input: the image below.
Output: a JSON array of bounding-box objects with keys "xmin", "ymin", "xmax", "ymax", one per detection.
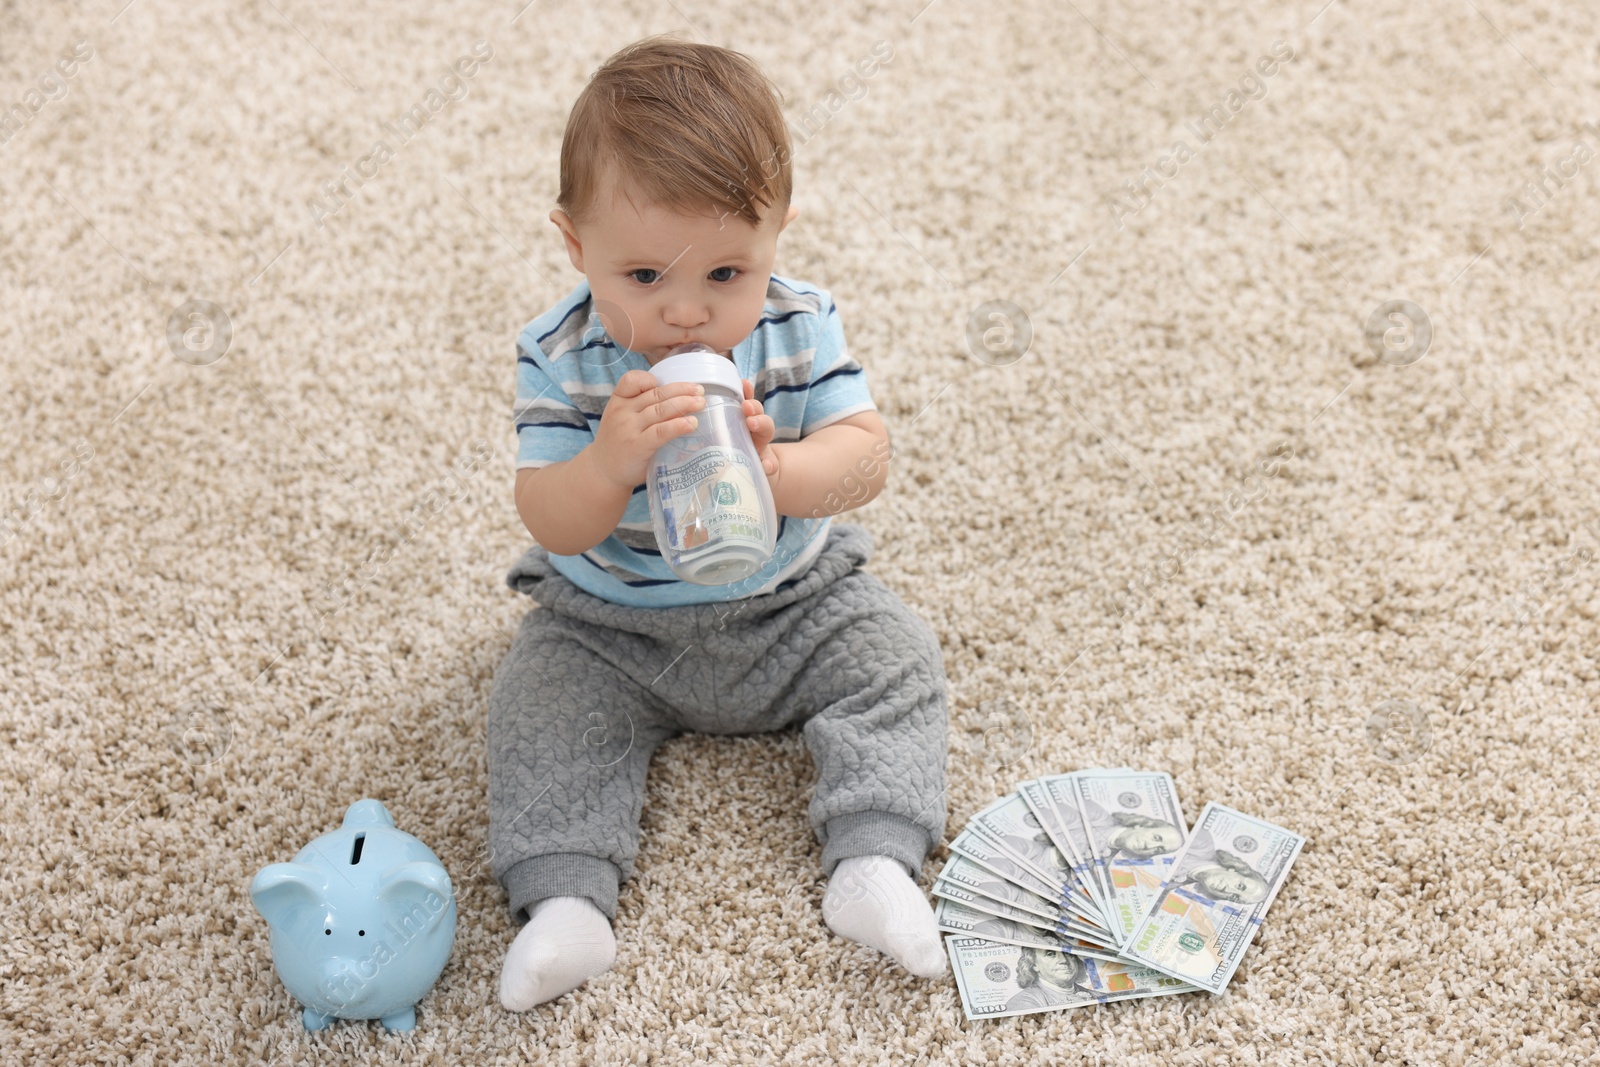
[{"xmin": 944, "ymin": 937, "xmax": 1194, "ymax": 1019}]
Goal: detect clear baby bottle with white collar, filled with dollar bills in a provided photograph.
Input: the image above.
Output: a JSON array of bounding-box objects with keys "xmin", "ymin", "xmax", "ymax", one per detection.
[{"xmin": 645, "ymin": 344, "xmax": 778, "ymax": 585}]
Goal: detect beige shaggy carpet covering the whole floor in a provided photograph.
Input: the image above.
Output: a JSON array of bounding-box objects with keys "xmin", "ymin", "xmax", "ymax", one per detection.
[{"xmin": 0, "ymin": 0, "xmax": 1600, "ymax": 1067}]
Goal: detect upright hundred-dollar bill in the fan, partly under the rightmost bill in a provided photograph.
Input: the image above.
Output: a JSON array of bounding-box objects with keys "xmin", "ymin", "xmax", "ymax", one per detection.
[{"xmin": 1072, "ymin": 771, "xmax": 1189, "ymax": 944}]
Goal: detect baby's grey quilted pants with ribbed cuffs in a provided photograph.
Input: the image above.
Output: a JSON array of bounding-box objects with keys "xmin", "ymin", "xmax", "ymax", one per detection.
[{"xmin": 488, "ymin": 520, "xmax": 947, "ymax": 923}]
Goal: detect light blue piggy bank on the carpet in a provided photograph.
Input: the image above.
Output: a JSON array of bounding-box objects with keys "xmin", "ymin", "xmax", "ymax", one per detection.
[{"xmin": 250, "ymin": 798, "xmax": 456, "ymax": 1030}]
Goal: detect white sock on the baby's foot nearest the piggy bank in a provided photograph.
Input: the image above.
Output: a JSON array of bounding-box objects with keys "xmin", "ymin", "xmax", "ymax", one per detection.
[{"xmin": 501, "ymin": 896, "xmax": 616, "ymax": 1011}]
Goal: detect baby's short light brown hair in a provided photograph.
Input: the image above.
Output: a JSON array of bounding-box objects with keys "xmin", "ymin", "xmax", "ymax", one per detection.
[{"xmin": 555, "ymin": 34, "xmax": 792, "ymax": 226}]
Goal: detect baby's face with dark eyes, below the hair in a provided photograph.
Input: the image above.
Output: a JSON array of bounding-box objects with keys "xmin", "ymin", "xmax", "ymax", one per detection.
[{"xmin": 550, "ymin": 171, "xmax": 798, "ymax": 366}]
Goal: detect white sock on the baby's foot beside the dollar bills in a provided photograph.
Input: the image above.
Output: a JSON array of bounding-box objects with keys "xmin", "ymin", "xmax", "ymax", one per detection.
[{"xmin": 822, "ymin": 856, "xmax": 950, "ymax": 977}]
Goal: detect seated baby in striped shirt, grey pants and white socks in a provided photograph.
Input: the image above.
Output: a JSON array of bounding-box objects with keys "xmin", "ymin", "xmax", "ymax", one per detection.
[{"xmin": 488, "ymin": 37, "xmax": 947, "ymax": 1011}]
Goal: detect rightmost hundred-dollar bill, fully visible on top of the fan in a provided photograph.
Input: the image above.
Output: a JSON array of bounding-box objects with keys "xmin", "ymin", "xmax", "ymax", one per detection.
[{"xmin": 1123, "ymin": 803, "xmax": 1306, "ymax": 993}]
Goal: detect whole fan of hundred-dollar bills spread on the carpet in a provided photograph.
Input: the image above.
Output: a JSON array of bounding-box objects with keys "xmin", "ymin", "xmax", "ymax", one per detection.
[{"xmin": 933, "ymin": 768, "xmax": 1306, "ymax": 1019}]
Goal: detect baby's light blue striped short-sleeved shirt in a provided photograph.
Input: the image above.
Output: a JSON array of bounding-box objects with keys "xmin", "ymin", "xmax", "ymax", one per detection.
[{"xmin": 512, "ymin": 274, "xmax": 877, "ymax": 608}]
